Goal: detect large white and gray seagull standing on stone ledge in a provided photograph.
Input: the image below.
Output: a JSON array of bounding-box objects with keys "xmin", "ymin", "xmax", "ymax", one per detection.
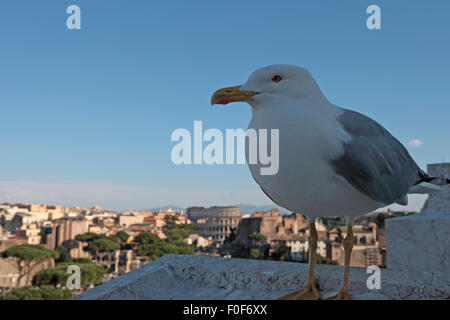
[{"xmin": 211, "ymin": 65, "xmax": 450, "ymax": 300}]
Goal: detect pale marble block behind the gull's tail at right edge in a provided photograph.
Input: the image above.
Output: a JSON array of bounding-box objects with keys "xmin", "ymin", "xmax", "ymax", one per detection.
[{"xmin": 386, "ymin": 163, "xmax": 450, "ymax": 275}]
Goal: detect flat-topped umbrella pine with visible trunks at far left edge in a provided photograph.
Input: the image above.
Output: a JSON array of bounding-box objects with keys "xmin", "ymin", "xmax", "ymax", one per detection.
[{"xmin": 0, "ymin": 244, "xmax": 59, "ymax": 287}]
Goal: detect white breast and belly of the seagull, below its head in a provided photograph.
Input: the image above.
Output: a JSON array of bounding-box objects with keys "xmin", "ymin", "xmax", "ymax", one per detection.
[{"xmin": 246, "ymin": 102, "xmax": 379, "ymax": 217}]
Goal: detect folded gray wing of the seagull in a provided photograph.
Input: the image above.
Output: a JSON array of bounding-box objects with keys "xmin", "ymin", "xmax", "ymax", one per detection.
[{"xmin": 332, "ymin": 109, "xmax": 422, "ymax": 204}]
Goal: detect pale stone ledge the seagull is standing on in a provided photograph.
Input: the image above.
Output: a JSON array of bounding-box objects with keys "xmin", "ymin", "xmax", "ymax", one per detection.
[{"xmin": 74, "ymin": 255, "xmax": 450, "ymax": 300}]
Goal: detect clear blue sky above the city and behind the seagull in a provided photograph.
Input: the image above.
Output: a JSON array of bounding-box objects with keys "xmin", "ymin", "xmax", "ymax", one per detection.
[{"xmin": 0, "ymin": 0, "xmax": 450, "ymax": 209}]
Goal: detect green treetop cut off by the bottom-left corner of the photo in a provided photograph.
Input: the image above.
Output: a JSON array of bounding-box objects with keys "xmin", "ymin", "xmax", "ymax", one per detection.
[{"xmin": 0, "ymin": 286, "xmax": 72, "ymax": 300}]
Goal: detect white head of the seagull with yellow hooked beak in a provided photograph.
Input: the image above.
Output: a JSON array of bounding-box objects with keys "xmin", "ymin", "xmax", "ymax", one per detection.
[{"xmin": 211, "ymin": 64, "xmax": 322, "ymax": 107}]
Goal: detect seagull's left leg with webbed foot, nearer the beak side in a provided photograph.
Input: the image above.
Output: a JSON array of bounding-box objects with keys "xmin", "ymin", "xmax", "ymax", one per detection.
[{"xmin": 278, "ymin": 222, "xmax": 320, "ymax": 300}]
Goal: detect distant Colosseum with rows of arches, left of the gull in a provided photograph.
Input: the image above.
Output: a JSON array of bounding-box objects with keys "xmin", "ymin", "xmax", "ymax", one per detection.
[{"xmin": 187, "ymin": 207, "xmax": 242, "ymax": 242}]
